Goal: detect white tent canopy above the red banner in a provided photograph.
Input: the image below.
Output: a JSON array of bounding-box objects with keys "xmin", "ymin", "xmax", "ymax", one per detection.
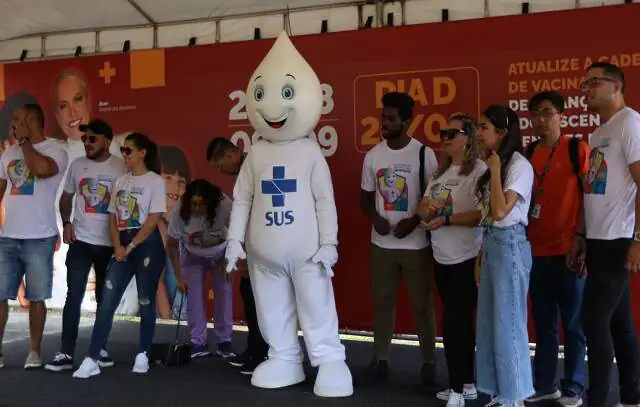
[{"xmin": 0, "ymin": 0, "xmax": 638, "ymax": 60}]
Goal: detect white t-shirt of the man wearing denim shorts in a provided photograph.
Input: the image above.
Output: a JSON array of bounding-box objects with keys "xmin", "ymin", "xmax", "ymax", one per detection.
[{"xmin": 0, "ymin": 139, "xmax": 68, "ymax": 239}]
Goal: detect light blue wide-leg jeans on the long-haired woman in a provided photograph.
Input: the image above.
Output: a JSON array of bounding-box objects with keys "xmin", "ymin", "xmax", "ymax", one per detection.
[{"xmin": 476, "ymin": 224, "xmax": 534, "ymax": 405}]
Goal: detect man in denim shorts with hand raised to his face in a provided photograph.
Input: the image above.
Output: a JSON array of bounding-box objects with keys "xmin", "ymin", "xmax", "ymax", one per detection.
[{"xmin": 0, "ymin": 104, "xmax": 67, "ymax": 369}]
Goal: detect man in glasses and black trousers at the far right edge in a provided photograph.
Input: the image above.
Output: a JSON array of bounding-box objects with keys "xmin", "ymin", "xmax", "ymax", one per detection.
[{"xmin": 582, "ymin": 62, "xmax": 640, "ymax": 407}]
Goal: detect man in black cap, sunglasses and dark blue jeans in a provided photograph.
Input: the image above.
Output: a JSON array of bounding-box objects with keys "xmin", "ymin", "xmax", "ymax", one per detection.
[{"xmin": 45, "ymin": 120, "xmax": 126, "ymax": 372}]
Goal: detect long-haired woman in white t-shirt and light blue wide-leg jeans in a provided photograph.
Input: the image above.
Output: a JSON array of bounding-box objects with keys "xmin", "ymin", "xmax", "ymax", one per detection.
[{"xmin": 476, "ymin": 105, "xmax": 534, "ymax": 406}]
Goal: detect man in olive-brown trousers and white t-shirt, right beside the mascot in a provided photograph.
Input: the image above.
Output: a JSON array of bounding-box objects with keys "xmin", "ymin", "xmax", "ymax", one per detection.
[{"xmin": 361, "ymin": 92, "xmax": 438, "ymax": 394}]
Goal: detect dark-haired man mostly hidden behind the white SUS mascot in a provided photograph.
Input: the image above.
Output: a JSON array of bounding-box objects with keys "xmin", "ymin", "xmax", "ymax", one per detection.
[{"xmin": 207, "ymin": 137, "xmax": 269, "ymax": 375}]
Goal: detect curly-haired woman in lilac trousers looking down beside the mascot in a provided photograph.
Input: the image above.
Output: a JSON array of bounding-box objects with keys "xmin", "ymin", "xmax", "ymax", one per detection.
[{"xmin": 167, "ymin": 179, "xmax": 235, "ymax": 358}]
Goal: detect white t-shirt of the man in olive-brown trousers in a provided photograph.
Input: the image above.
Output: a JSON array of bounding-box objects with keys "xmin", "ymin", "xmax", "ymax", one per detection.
[{"xmin": 361, "ymin": 139, "xmax": 438, "ymax": 250}]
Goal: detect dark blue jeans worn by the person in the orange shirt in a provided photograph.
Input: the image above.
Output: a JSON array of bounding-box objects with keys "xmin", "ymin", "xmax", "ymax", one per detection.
[{"xmin": 531, "ymin": 256, "xmax": 586, "ymax": 396}]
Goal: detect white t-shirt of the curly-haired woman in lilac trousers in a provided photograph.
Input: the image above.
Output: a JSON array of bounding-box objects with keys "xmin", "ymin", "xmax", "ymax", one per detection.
[{"xmin": 168, "ymin": 195, "xmax": 232, "ymax": 257}]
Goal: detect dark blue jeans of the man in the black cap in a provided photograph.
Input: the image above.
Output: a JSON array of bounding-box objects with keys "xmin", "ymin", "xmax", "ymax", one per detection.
[{"xmin": 60, "ymin": 240, "xmax": 113, "ymax": 357}]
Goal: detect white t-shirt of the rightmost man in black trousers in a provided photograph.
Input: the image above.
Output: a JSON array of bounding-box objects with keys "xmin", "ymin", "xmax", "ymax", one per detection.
[{"xmin": 584, "ymin": 107, "xmax": 640, "ymax": 240}]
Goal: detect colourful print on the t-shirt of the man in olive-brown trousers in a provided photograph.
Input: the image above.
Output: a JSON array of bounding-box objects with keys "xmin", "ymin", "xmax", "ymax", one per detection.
[{"xmin": 376, "ymin": 165, "xmax": 411, "ymax": 212}]
